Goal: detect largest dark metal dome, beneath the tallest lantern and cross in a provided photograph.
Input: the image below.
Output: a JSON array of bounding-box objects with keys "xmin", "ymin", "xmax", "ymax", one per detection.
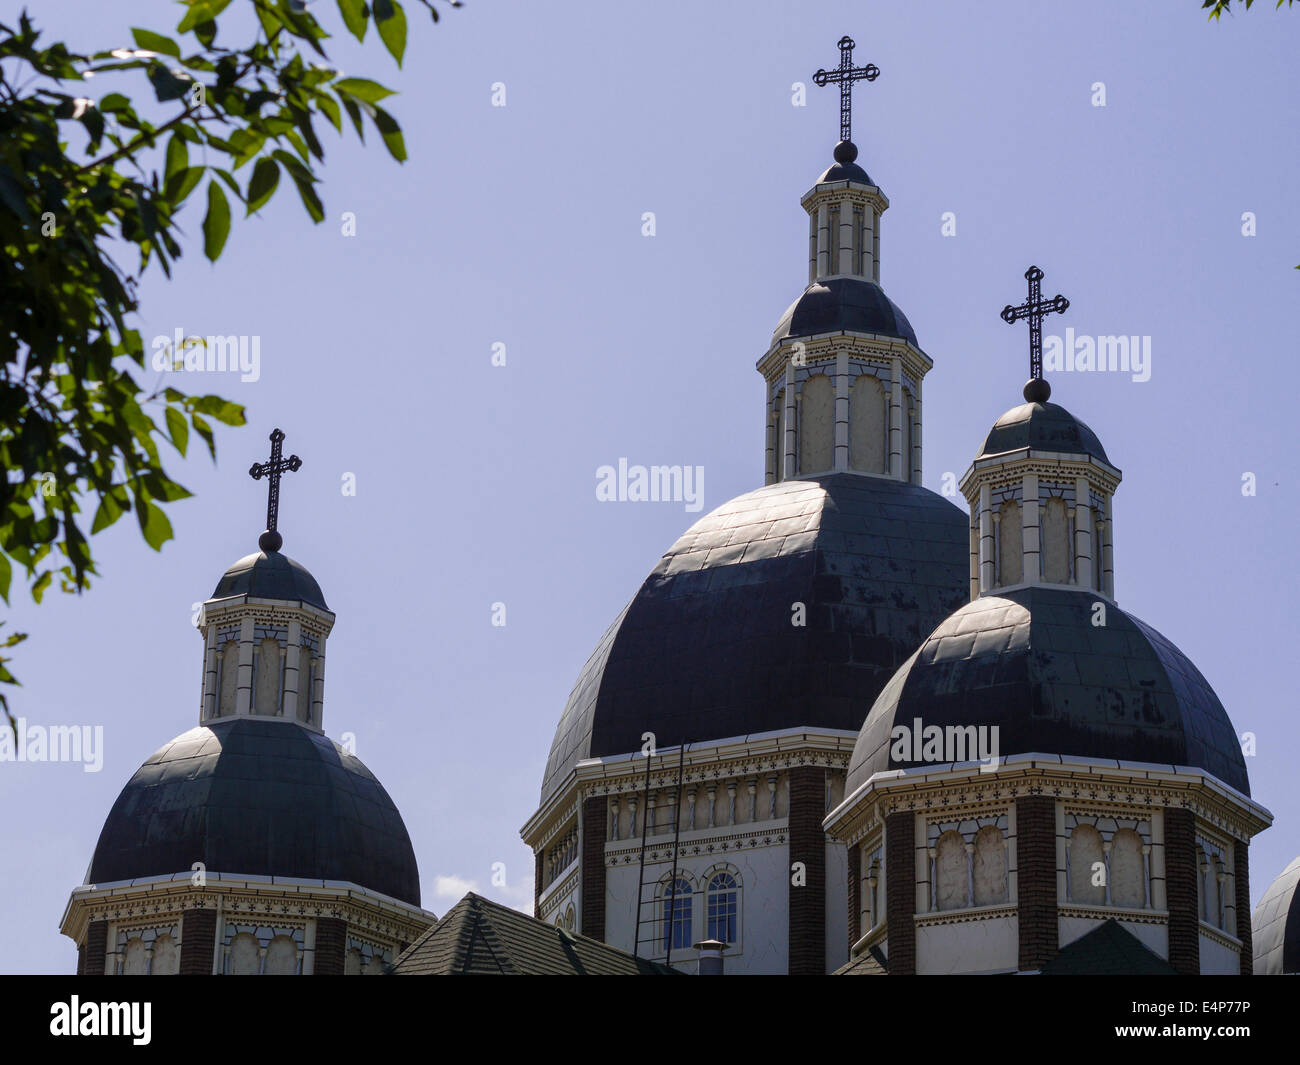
[{"xmin": 542, "ymin": 473, "xmax": 970, "ymax": 802}]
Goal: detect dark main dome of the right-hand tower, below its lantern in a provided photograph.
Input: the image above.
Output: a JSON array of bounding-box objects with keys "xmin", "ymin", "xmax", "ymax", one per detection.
[{"xmin": 845, "ymin": 586, "xmax": 1251, "ymax": 796}]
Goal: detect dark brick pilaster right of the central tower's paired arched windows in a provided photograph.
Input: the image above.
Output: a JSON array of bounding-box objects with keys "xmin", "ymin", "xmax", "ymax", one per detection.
[{"xmin": 789, "ymin": 766, "xmax": 826, "ymax": 975}]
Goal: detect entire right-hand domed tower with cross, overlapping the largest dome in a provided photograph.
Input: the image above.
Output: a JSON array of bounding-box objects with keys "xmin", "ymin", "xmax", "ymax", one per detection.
[{"xmin": 823, "ymin": 267, "xmax": 1277, "ymax": 975}]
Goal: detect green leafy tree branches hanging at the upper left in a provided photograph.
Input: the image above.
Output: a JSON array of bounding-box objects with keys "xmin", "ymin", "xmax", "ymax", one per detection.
[{"xmin": 0, "ymin": 0, "xmax": 459, "ymax": 722}]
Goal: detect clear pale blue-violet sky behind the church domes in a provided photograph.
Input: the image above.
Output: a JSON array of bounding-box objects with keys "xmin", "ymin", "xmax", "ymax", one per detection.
[{"xmin": 0, "ymin": 0, "xmax": 1300, "ymax": 973}]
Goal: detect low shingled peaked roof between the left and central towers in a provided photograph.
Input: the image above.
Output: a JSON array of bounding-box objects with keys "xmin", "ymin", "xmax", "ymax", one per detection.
[{"xmin": 393, "ymin": 892, "xmax": 681, "ymax": 977}]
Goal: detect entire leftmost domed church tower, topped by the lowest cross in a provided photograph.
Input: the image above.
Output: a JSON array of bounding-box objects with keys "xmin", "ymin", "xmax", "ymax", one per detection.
[{"xmin": 62, "ymin": 429, "xmax": 433, "ymax": 975}]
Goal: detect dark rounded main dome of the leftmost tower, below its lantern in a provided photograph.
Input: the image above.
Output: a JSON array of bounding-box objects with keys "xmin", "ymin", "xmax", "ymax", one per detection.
[{"xmin": 87, "ymin": 717, "xmax": 420, "ymax": 906}]
